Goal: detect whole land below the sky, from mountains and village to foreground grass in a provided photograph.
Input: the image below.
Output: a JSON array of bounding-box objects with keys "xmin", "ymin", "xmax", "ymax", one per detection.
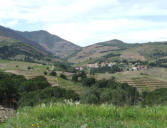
[{"xmin": 0, "ymin": 26, "xmax": 167, "ymax": 128}]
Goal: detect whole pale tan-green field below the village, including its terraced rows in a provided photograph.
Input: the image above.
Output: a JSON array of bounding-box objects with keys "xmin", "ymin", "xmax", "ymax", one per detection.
[{"xmin": 95, "ymin": 68, "xmax": 167, "ymax": 91}]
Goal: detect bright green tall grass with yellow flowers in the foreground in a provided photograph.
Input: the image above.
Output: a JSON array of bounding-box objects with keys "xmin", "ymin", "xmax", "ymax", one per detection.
[{"xmin": 0, "ymin": 103, "xmax": 167, "ymax": 128}]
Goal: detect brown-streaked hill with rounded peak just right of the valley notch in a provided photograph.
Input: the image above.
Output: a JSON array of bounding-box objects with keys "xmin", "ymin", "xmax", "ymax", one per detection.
[{"xmin": 68, "ymin": 39, "xmax": 138, "ymax": 63}]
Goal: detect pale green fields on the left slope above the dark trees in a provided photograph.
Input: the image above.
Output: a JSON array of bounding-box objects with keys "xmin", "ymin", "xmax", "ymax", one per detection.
[{"xmin": 0, "ymin": 60, "xmax": 85, "ymax": 93}]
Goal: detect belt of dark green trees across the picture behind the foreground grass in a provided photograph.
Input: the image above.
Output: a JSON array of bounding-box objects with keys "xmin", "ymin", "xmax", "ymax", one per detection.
[{"xmin": 0, "ymin": 72, "xmax": 167, "ymax": 107}]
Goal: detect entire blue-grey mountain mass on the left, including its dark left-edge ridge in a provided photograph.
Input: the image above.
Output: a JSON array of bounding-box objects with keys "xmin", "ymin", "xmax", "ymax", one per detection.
[{"xmin": 0, "ymin": 26, "xmax": 81, "ymax": 58}]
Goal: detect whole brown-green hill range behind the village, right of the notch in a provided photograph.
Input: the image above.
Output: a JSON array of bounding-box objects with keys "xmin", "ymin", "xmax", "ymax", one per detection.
[{"xmin": 68, "ymin": 39, "xmax": 167, "ymax": 65}]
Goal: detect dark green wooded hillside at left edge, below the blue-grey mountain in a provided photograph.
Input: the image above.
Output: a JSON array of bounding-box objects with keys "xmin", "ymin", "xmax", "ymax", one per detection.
[{"xmin": 0, "ymin": 36, "xmax": 49, "ymax": 60}]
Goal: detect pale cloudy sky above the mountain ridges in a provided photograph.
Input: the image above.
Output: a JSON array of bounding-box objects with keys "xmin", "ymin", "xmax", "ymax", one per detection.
[{"xmin": 0, "ymin": 0, "xmax": 167, "ymax": 46}]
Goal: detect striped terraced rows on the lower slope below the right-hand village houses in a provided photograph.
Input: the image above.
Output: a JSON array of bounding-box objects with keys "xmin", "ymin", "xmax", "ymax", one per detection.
[{"xmin": 120, "ymin": 77, "xmax": 167, "ymax": 91}]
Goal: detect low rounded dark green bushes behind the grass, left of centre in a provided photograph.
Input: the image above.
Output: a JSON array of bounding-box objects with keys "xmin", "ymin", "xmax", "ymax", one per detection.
[{"xmin": 19, "ymin": 87, "xmax": 79, "ymax": 107}]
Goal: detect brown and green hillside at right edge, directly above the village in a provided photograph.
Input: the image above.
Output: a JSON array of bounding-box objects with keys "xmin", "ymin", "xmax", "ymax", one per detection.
[{"xmin": 121, "ymin": 42, "xmax": 167, "ymax": 61}]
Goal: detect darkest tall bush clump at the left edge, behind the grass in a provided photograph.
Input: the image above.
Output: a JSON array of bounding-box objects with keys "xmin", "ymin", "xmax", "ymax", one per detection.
[{"xmin": 0, "ymin": 73, "xmax": 26, "ymax": 107}]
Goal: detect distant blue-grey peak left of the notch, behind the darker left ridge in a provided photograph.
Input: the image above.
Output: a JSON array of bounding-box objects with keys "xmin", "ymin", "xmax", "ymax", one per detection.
[{"xmin": 18, "ymin": 30, "xmax": 81, "ymax": 58}]
